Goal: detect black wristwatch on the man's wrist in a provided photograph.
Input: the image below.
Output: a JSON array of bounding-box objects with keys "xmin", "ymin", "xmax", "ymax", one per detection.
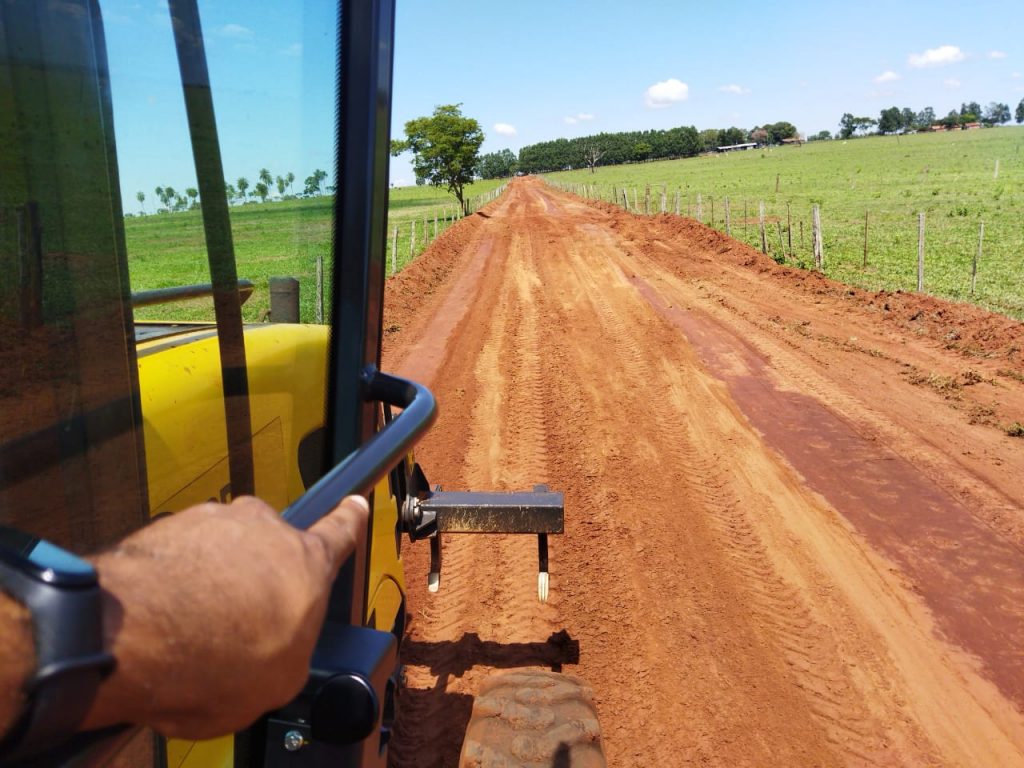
[{"xmin": 0, "ymin": 525, "xmax": 114, "ymax": 763}]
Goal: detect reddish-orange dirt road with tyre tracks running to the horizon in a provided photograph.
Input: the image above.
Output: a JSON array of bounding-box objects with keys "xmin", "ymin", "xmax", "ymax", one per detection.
[{"xmin": 385, "ymin": 179, "xmax": 1024, "ymax": 766}]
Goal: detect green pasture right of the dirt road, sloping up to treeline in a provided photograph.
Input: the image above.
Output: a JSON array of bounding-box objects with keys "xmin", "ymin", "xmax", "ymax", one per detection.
[{"xmin": 548, "ymin": 126, "xmax": 1024, "ymax": 318}]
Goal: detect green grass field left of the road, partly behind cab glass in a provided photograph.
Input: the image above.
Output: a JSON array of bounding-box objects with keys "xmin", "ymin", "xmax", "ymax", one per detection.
[{"xmin": 125, "ymin": 181, "xmax": 503, "ymax": 323}]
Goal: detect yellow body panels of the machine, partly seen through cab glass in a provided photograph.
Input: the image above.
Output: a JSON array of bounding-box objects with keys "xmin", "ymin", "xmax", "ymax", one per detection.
[{"xmin": 137, "ymin": 323, "xmax": 406, "ymax": 768}]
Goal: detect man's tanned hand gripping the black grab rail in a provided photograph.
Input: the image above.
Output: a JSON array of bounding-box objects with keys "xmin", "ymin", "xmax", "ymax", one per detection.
[{"xmin": 83, "ymin": 497, "xmax": 369, "ymax": 738}]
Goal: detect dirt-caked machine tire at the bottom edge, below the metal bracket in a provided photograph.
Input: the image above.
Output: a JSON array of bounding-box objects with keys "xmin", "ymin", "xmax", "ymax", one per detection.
[{"xmin": 459, "ymin": 670, "xmax": 607, "ymax": 768}]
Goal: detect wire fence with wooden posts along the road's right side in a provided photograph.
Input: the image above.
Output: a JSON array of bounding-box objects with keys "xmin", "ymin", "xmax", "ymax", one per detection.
[{"xmin": 547, "ymin": 179, "xmax": 1024, "ymax": 318}]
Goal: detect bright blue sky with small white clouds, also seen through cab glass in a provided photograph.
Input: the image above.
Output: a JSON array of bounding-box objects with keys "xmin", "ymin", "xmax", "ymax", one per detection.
[{"xmin": 101, "ymin": 0, "xmax": 1024, "ymax": 211}]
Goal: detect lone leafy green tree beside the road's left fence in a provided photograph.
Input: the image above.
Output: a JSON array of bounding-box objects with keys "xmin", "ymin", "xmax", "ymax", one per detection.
[{"xmin": 391, "ymin": 104, "xmax": 483, "ymax": 210}]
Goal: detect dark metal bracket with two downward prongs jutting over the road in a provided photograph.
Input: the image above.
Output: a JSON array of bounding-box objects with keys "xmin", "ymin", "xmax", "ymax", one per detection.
[{"xmin": 402, "ymin": 464, "xmax": 565, "ymax": 602}]
